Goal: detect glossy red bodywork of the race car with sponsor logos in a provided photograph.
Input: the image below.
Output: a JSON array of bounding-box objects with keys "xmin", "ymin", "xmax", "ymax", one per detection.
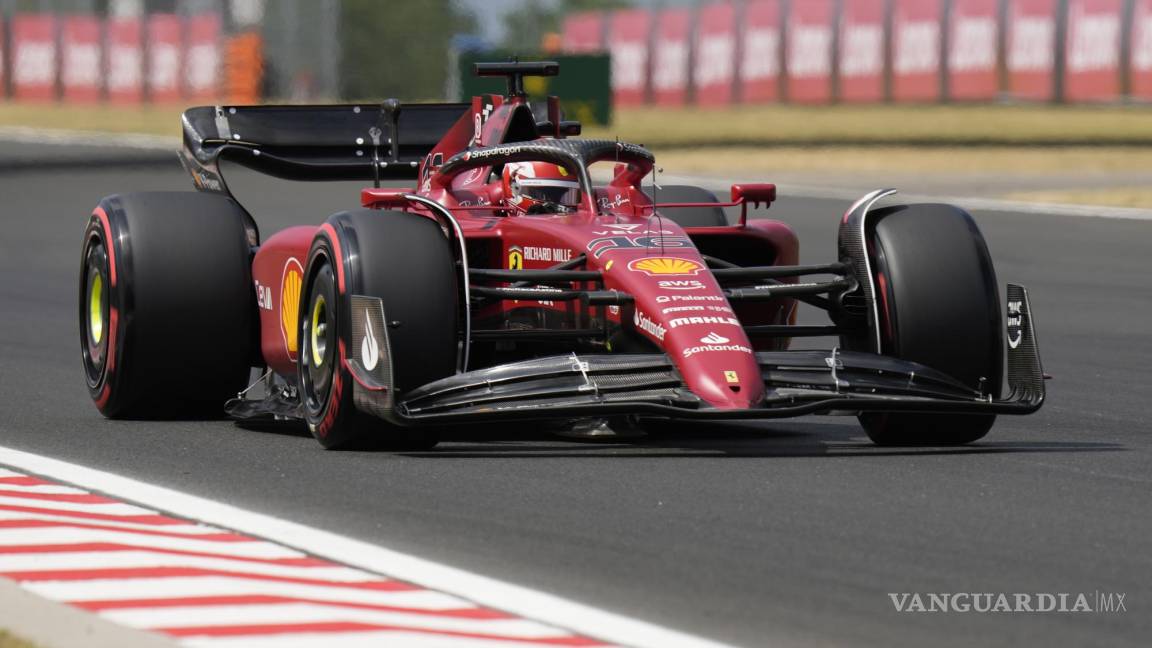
[{"xmin": 252, "ymin": 96, "xmax": 798, "ymax": 409}]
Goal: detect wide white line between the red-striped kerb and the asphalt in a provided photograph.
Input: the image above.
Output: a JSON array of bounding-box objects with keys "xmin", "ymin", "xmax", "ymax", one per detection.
[{"xmin": 0, "ymin": 446, "xmax": 725, "ymax": 648}]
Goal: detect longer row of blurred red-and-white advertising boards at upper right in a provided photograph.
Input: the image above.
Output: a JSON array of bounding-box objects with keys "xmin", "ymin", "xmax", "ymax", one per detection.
[{"xmin": 561, "ymin": 0, "xmax": 1152, "ymax": 106}]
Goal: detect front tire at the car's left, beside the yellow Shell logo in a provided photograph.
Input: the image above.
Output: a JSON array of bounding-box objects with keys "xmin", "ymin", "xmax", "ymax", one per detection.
[{"xmin": 297, "ymin": 210, "xmax": 460, "ymax": 450}]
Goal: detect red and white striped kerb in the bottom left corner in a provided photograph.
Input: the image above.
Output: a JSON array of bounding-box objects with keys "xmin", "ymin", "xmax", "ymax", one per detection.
[{"xmin": 0, "ymin": 468, "xmax": 605, "ymax": 648}]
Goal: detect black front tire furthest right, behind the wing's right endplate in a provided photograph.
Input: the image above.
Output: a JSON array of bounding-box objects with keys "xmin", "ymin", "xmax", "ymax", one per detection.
[{"xmin": 859, "ymin": 204, "xmax": 1003, "ymax": 445}]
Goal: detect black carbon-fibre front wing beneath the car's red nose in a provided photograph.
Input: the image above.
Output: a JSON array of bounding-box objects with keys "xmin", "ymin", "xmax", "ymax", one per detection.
[{"xmin": 348, "ymin": 284, "xmax": 1045, "ymax": 424}]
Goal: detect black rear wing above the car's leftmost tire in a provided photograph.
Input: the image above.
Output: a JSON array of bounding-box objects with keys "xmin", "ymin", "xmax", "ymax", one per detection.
[{"xmin": 180, "ymin": 99, "xmax": 471, "ymax": 194}]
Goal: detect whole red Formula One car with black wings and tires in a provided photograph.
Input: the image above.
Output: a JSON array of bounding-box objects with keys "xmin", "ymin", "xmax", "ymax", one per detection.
[{"xmin": 79, "ymin": 62, "xmax": 1045, "ymax": 447}]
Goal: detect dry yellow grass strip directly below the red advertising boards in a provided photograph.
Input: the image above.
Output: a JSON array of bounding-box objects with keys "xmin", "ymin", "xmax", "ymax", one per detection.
[{"xmin": 0, "ymin": 103, "xmax": 1152, "ymax": 148}]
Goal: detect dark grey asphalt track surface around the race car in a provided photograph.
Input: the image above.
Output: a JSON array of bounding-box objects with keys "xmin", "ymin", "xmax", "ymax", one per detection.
[{"xmin": 0, "ymin": 144, "xmax": 1152, "ymax": 646}]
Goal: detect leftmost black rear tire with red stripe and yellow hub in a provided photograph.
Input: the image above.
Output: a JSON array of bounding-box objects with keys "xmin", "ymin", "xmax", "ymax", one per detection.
[{"xmin": 79, "ymin": 191, "xmax": 257, "ymax": 419}]
